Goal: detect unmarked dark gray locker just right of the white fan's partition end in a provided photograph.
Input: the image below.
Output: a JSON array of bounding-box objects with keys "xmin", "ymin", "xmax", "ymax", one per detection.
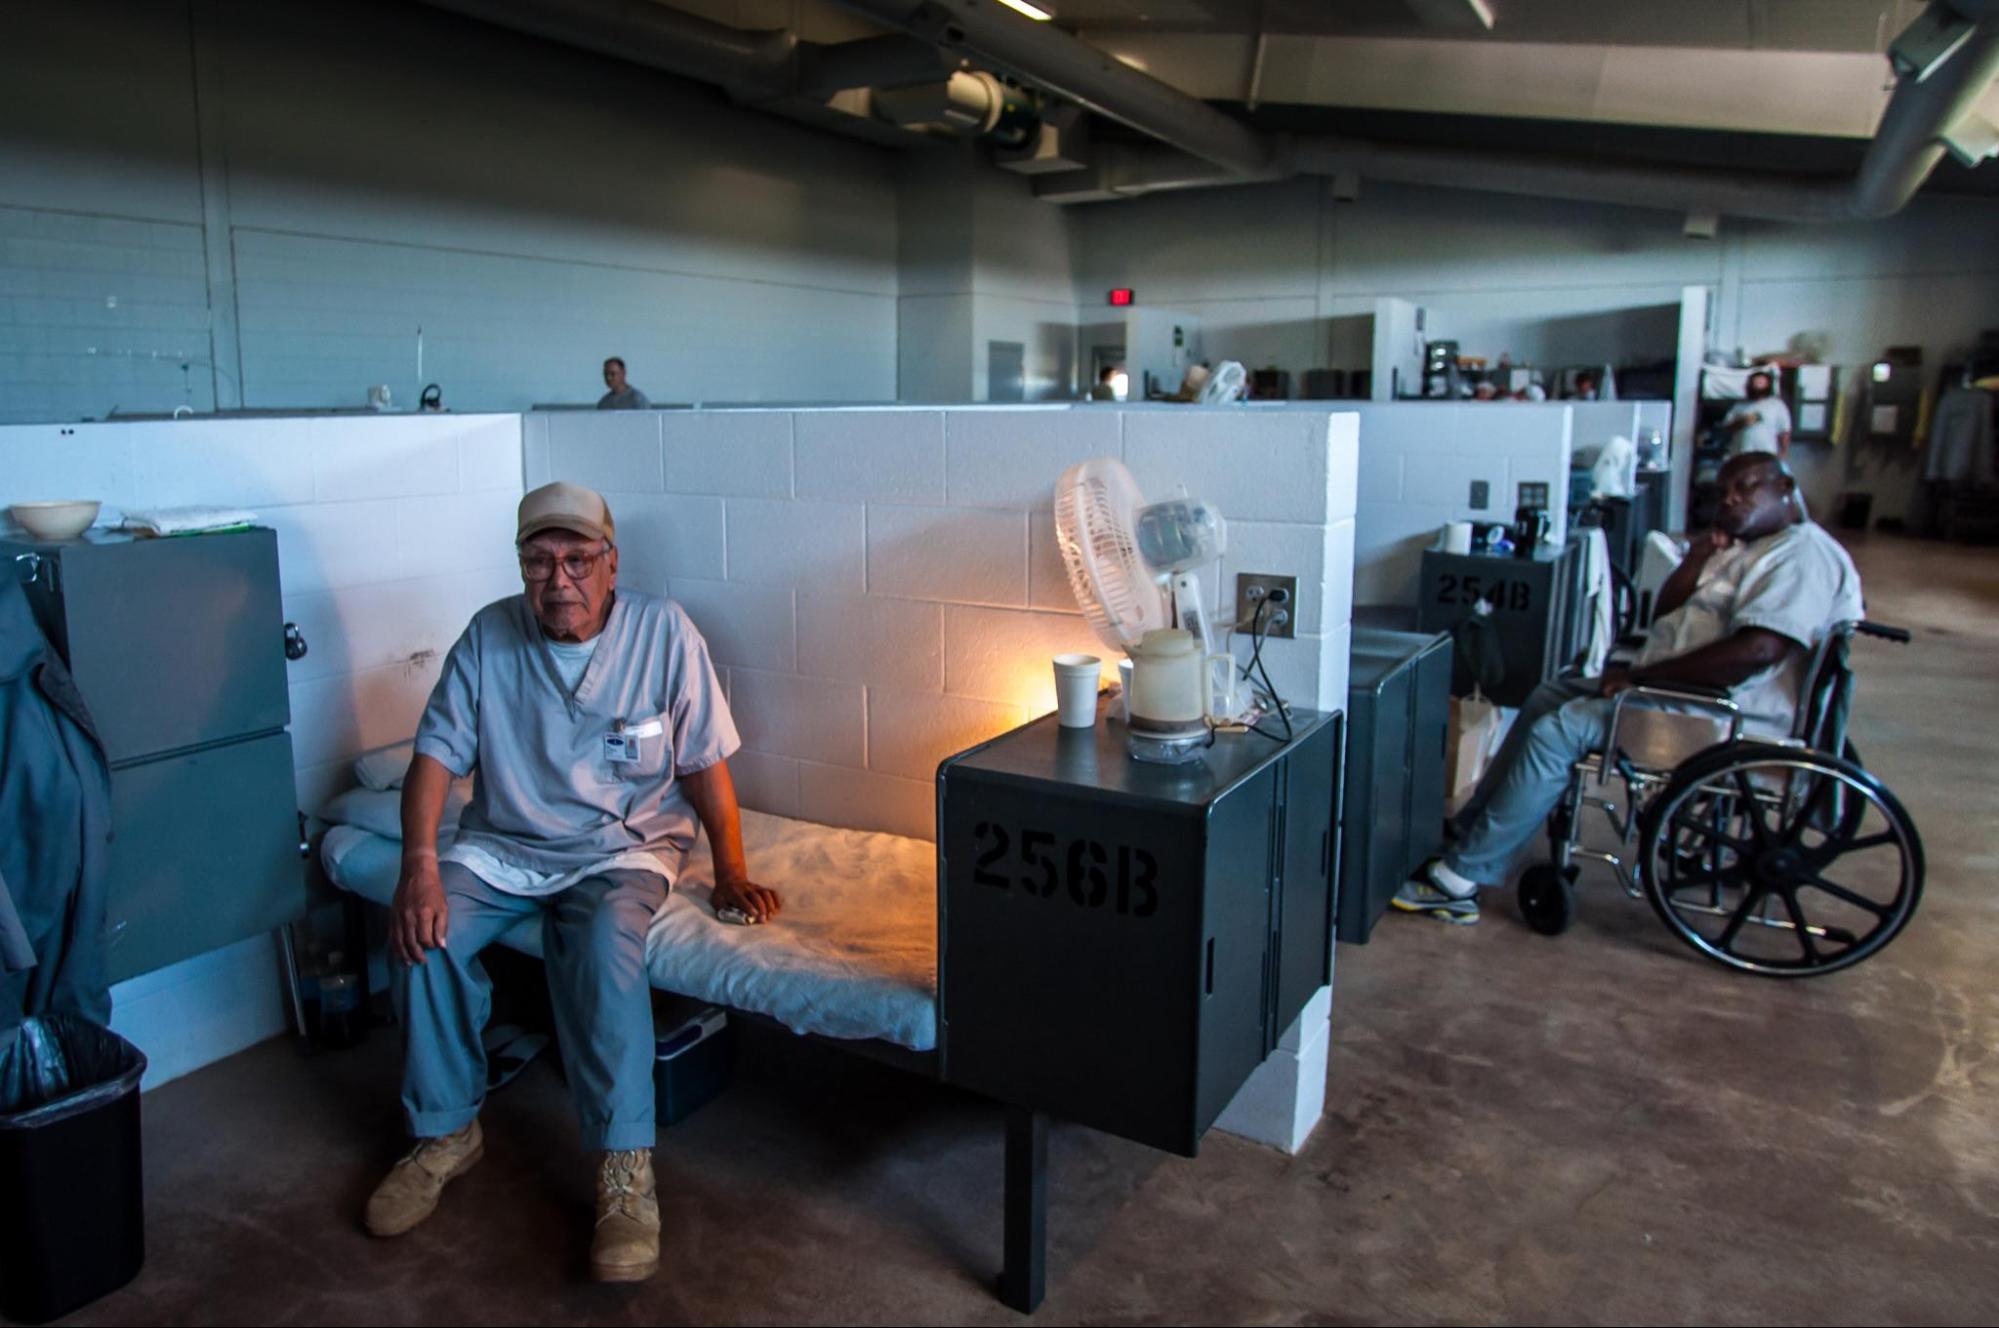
[{"xmin": 1339, "ymin": 628, "xmax": 1451, "ymax": 944}]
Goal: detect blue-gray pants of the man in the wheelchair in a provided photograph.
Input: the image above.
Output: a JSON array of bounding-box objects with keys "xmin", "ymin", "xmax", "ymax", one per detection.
[{"xmin": 1443, "ymin": 678, "xmax": 1617, "ymax": 886}]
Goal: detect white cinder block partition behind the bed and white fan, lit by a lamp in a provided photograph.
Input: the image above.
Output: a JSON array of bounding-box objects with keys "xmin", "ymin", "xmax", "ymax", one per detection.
[{"xmin": 539, "ymin": 406, "xmax": 1355, "ymax": 838}]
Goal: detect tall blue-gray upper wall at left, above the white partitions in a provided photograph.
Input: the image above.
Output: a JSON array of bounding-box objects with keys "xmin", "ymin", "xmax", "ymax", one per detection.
[{"xmin": 0, "ymin": 0, "xmax": 896, "ymax": 420}]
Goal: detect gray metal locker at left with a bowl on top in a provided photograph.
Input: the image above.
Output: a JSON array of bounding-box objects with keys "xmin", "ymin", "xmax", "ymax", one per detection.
[{"xmin": 0, "ymin": 530, "xmax": 306, "ymax": 982}]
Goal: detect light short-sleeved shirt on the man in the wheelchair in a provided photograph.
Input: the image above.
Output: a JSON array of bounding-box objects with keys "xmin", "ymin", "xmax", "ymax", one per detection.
[{"xmin": 1637, "ymin": 522, "xmax": 1865, "ymax": 738}]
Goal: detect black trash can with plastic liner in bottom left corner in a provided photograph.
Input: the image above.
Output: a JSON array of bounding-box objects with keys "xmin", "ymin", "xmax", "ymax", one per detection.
[{"xmin": 0, "ymin": 1014, "xmax": 146, "ymax": 1324}]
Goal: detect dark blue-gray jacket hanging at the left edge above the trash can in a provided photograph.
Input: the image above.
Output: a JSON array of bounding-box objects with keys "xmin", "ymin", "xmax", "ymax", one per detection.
[{"xmin": 0, "ymin": 568, "xmax": 112, "ymax": 1030}]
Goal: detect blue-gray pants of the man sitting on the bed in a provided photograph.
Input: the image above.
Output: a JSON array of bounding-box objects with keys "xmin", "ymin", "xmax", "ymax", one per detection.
[{"xmin": 396, "ymin": 862, "xmax": 666, "ymax": 1152}]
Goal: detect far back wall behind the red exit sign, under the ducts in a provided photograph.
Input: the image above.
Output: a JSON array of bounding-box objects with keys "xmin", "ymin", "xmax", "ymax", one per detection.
[{"xmin": 1077, "ymin": 180, "xmax": 1999, "ymax": 508}]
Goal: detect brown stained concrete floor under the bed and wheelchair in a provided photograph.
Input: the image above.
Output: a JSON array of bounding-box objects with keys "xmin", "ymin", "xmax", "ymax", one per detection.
[{"xmin": 50, "ymin": 536, "xmax": 1999, "ymax": 1324}]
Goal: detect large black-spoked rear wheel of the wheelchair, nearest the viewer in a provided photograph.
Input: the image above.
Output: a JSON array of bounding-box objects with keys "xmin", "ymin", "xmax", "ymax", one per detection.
[{"xmin": 1637, "ymin": 742, "xmax": 1923, "ymax": 978}]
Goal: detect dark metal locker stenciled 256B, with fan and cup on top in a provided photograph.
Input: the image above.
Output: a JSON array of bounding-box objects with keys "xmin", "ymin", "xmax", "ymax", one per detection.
[{"xmin": 938, "ymin": 712, "xmax": 1341, "ymax": 1156}]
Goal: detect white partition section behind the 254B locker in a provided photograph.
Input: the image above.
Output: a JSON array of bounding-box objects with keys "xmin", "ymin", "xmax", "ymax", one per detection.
[{"xmin": 1353, "ymin": 402, "xmax": 1573, "ymax": 606}]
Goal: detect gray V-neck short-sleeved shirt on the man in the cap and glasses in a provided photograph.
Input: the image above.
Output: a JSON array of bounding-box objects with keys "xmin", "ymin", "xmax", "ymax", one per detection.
[{"xmin": 416, "ymin": 590, "xmax": 742, "ymax": 894}]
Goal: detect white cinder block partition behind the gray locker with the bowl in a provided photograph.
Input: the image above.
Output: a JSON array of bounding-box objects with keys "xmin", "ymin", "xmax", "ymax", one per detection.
[{"xmin": 0, "ymin": 414, "xmax": 522, "ymax": 1086}]
